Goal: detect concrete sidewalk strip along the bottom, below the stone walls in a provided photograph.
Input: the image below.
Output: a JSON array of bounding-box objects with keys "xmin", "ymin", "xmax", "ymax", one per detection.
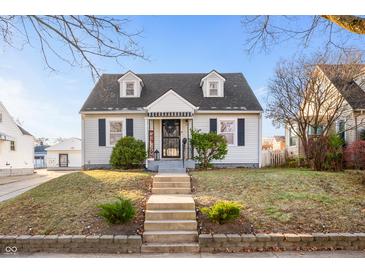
[{"xmin": 0, "ymin": 250, "xmax": 365, "ymax": 258}]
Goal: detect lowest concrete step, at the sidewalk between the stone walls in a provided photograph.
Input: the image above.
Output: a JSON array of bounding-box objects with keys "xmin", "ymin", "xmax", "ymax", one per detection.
[{"xmin": 141, "ymin": 243, "xmax": 199, "ymax": 253}]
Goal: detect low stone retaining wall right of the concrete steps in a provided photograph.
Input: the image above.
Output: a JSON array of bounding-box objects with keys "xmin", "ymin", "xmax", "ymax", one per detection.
[{"xmin": 199, "ymin": 233, "xmax": 365, "ymax": 252}]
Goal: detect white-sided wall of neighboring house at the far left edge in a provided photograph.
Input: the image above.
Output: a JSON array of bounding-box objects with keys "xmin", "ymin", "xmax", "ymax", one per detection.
[{"xmin": 0, "ymin": 103, "xmax": 34, "ymax": 174}]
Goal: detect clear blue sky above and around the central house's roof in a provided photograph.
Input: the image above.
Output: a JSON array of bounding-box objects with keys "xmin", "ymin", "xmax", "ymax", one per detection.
[{"xmin": 0, "ymin": 16, "xmax": 358, "ymax": 137}]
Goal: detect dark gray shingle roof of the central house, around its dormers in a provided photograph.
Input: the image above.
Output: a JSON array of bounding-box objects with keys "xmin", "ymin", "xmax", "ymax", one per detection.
[{"xmin": 81, "ymin": 73, "xmax": 262, "ymax": 111}]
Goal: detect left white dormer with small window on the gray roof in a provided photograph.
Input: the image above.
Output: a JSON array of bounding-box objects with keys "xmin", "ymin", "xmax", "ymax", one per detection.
[{"xmin": 118, "ymin": 71, "xmax": 144, "ymax": 98}]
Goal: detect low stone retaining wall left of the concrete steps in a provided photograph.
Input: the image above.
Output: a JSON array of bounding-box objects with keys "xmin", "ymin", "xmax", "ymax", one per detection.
[{"xmin": 0, "ymin": 235, "xmax": 142, "ymax": 254}]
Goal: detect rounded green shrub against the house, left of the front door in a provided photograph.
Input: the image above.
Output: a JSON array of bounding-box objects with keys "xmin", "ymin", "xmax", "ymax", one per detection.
[{"xmin": 110, "ymin": 136, "xmax": 147, "ymax": 169}]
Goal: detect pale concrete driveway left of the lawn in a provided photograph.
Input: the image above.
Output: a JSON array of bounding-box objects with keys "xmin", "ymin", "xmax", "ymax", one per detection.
[{"xmin": 0, "ymin": 169, "xmax": 75, "ymax": 202}]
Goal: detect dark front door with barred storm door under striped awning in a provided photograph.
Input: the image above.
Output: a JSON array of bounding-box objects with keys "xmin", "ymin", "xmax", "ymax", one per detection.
[{"xmin": 162, "ymin": 119, "xmax": 180, "ymax": 158}]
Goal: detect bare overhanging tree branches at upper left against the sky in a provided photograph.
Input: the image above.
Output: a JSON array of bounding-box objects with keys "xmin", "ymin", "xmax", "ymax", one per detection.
[{"xmin": 0, "ymin": 15, "xmax": 145, "ymax": 77}]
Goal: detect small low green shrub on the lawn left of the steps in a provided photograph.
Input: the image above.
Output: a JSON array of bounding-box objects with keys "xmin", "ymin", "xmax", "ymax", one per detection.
[{"xmin": 98, "ymin": 197, "xmax": 136, "ymax": 224}]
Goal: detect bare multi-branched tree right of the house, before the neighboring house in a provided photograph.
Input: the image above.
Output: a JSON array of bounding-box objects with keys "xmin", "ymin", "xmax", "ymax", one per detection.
[{"xmin": 266, "ymin": 50, "xmax": 364, "ymax": 163}]
